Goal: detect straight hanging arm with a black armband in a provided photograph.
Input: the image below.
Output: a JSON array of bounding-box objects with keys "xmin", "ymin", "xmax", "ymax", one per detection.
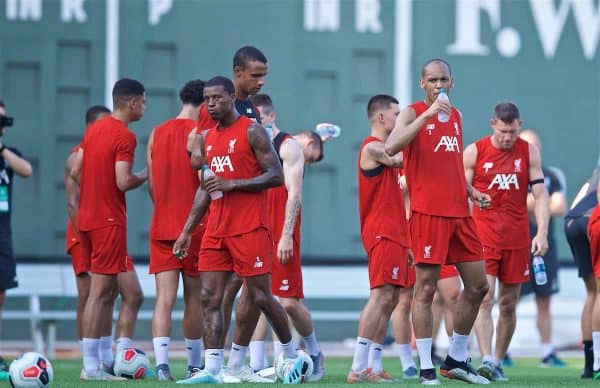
[{"xmin": 529, "ymin": 144, "xmax": 550, "ymax": 255}]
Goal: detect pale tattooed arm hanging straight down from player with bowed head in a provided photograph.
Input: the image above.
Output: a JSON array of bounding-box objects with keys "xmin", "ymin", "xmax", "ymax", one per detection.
[{"xmin": 277, "ymin": 139, "xmax": 304, "ymax": 264}]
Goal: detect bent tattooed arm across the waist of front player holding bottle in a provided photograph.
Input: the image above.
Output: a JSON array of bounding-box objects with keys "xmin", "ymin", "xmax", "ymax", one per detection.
[{"xmin": 204, "ymin": 123, "xmax": 283, "ymax": 193}]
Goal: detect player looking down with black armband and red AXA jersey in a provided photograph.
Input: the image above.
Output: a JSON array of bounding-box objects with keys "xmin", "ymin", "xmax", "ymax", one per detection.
[{"xmin": 463, "ymin": 102, "xmax": 549, "ymax": 381}]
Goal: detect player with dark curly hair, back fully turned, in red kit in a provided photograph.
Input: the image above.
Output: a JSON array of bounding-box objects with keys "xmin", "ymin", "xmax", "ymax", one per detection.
[{"xmin": 146, "ymin": 80, "xmax": 204, "ymax": 381}]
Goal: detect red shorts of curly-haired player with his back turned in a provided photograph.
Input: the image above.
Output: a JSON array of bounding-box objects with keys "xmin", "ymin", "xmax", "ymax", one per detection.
[{"xmin": 148, "ymin": 235, "xmax": 202, "ymax": 276}]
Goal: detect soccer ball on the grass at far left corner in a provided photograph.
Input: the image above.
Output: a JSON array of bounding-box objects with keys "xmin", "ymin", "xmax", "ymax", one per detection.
[{"xmin": 8, "ymin": 352, "xmax": 54, "ymax": 388}]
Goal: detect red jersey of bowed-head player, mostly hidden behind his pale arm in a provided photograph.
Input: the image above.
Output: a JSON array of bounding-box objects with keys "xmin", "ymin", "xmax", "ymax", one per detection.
[{"xmin": 267, "ymin": 132, "xmax": 302, "ymax": 243}]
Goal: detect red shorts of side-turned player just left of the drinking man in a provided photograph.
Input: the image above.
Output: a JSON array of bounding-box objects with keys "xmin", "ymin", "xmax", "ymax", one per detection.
[{"xmin": 369, "ymin": 238, "xmax": 415, "ymax": 289}]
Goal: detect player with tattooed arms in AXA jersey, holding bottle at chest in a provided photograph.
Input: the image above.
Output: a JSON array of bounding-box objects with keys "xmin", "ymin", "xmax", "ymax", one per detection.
[{"xmin": 173, "ymin": 77, "xmax": 302, "ymax": 384}]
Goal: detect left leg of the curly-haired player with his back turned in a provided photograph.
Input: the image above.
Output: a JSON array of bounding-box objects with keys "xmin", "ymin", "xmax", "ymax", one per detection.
[{"xmin": 152, "ymin": 269, "xmax": 180, "ymax": 380}]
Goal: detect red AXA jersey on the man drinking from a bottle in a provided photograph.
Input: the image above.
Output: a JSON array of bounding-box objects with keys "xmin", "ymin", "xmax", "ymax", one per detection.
[{"xmin": 402, "ymin": 101, "xmax": 469, "ymax": 217}]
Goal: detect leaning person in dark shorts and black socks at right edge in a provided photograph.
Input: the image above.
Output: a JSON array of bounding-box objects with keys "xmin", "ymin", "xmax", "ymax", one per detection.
[{"xmin": 565, "ymin": 166, "xmax": 600, "ymax": 378}]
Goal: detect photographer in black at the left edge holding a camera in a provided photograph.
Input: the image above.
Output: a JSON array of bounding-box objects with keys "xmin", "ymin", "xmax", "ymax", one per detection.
[{"xmin": 0, "ymin": 100, "xmax": 32, "ymax": 371}]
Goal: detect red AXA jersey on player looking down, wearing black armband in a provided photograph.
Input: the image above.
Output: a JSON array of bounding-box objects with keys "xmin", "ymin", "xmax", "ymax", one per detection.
[{"xmin": 473, "ymin": 136, "xmax": 531, "ymax": 249}]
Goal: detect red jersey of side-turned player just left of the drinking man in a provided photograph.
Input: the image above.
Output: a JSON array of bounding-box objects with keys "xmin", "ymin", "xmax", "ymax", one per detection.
[{"xmin": 358, "ymin": 136, "xmax": 408, "ymax": 252}]
